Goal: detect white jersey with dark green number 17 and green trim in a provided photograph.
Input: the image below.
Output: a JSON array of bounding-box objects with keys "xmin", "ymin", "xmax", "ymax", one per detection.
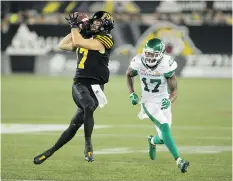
[{"xmin": 130, "ymin": 54, "xmax": 177, "ymax": 103}]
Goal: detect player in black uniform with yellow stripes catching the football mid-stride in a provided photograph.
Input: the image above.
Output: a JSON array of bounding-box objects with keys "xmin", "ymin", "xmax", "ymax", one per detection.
[{"xmin": 33, "ymin": 11, "xmax": 114, "ymax": 164}]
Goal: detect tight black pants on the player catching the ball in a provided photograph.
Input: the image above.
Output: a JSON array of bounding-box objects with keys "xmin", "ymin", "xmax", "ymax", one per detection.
[{"xmin": 51, "ymin": 82, "xmax": 98, "ymax": 152}]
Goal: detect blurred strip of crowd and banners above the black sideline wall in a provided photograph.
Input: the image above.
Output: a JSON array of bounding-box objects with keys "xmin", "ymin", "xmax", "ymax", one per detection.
[{"xmin": 1, "ymin": 0, "xmax": 232, "ymax": 26}]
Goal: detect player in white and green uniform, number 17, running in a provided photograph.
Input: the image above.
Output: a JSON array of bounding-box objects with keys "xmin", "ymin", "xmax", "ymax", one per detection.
[{"xmin": 126, "ymin": 38, "xmax": 189, "ymax": 173}]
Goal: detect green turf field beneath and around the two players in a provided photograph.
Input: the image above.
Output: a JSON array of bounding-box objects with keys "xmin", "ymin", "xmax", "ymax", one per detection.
[{"xmin": 1, "ymin": 76, "xmax": 232, "ymax": 181}]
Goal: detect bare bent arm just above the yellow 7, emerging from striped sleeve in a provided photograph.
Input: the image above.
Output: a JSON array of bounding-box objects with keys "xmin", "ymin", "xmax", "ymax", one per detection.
[{"xmin": 71, "ymin": 28, "xmax": 105, "ymax": 52}]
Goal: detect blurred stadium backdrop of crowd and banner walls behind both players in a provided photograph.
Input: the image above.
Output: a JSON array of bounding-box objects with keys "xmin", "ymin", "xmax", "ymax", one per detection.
[{"xmin": 1, "ymin": 0, "xmax": 232, "ymax": 77}]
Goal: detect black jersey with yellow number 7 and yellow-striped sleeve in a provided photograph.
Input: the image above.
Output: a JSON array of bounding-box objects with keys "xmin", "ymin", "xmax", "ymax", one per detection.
[{"xmin": 74, "ymin": 35, "xmax": 113, "ymax": 84}]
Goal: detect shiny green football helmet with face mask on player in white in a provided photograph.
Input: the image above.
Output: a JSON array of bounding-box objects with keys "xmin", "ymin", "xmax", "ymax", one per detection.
[{"xmin": 142, "ymin": 38, "xmax": 165, "ymax": 68}]
